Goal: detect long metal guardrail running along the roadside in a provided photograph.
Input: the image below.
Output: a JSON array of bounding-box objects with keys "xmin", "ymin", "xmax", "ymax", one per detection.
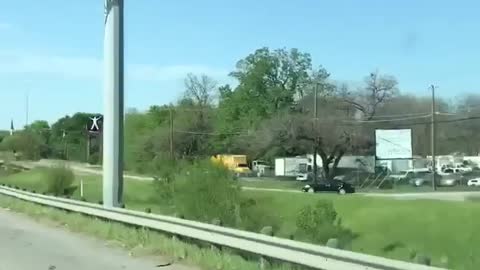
[{"xmin": 0, "ymin": 186, "xmax": 448, "ymax": 270}]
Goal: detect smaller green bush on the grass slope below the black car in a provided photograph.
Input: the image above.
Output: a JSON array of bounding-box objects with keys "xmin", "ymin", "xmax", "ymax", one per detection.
[{"xmin": 296, "ymin": 200, "xmax": 353, "ymax": 246}]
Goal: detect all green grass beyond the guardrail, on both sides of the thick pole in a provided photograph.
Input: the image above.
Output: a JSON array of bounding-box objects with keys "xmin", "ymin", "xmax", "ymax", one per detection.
[{"xmin": 0, "ymin": 170, "xmax": 480, "ymax": 270}]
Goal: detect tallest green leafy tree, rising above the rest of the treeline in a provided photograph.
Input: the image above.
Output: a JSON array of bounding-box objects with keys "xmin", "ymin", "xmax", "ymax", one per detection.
[{"xmin": 216, "ymin": 48, "xmax": 329, "ymax": 152}]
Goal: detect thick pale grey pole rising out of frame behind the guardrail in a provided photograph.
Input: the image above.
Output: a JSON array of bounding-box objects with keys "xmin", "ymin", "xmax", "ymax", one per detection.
[{"xmin": 103, "ymin": 0, "xmax": 123, "ymax": 207}]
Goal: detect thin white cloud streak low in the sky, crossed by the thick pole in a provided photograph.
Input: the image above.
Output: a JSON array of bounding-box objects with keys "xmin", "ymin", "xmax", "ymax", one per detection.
[{"xmin": 0, "ymin": 51, "xmax": 228, "ymax": 82}]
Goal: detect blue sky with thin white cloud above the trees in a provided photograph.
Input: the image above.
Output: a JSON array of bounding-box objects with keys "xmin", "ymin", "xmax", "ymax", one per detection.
[{"xmin": 0, "ymin": 0, "xmax": 480, "ymax": 129}]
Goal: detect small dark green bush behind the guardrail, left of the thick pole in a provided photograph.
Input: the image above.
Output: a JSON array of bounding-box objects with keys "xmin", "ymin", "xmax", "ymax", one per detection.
[{"xmin": 45, "ymin": 165, "xmax": 76, "ymax": 196}]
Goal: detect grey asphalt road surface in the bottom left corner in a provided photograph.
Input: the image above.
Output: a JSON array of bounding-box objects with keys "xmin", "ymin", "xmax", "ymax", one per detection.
[{"xmin": 0, "ymin": 208, "xmax": 192, "ymax": 270}]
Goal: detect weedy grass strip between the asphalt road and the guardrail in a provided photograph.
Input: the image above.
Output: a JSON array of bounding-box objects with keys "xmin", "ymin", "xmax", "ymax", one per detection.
[{"xmin": 0, "ymin": 195, "xmax": 301, "ymax": 270}]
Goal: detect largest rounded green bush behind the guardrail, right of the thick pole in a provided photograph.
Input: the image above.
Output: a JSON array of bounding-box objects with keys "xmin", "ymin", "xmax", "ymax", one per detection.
[{"xmin": 173, "ymin": 160, "xmax": 240, "ymax": 226}]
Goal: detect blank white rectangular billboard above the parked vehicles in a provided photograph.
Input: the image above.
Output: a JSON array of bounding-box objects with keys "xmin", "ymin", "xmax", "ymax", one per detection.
[{"xmin": 375, "ymin": 129, "xmax": 413, "ymax": 159}]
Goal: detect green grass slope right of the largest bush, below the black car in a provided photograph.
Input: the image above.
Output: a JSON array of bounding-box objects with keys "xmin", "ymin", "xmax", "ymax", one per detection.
[{"xmin": 249, "ymin": 191, "xmax": 480, "ymax": 269}]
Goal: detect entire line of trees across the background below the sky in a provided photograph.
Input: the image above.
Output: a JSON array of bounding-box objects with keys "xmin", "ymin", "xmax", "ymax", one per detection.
[{"xmin": 8, "ymin": 44, "xmax": 480, "ymax": 173}]
